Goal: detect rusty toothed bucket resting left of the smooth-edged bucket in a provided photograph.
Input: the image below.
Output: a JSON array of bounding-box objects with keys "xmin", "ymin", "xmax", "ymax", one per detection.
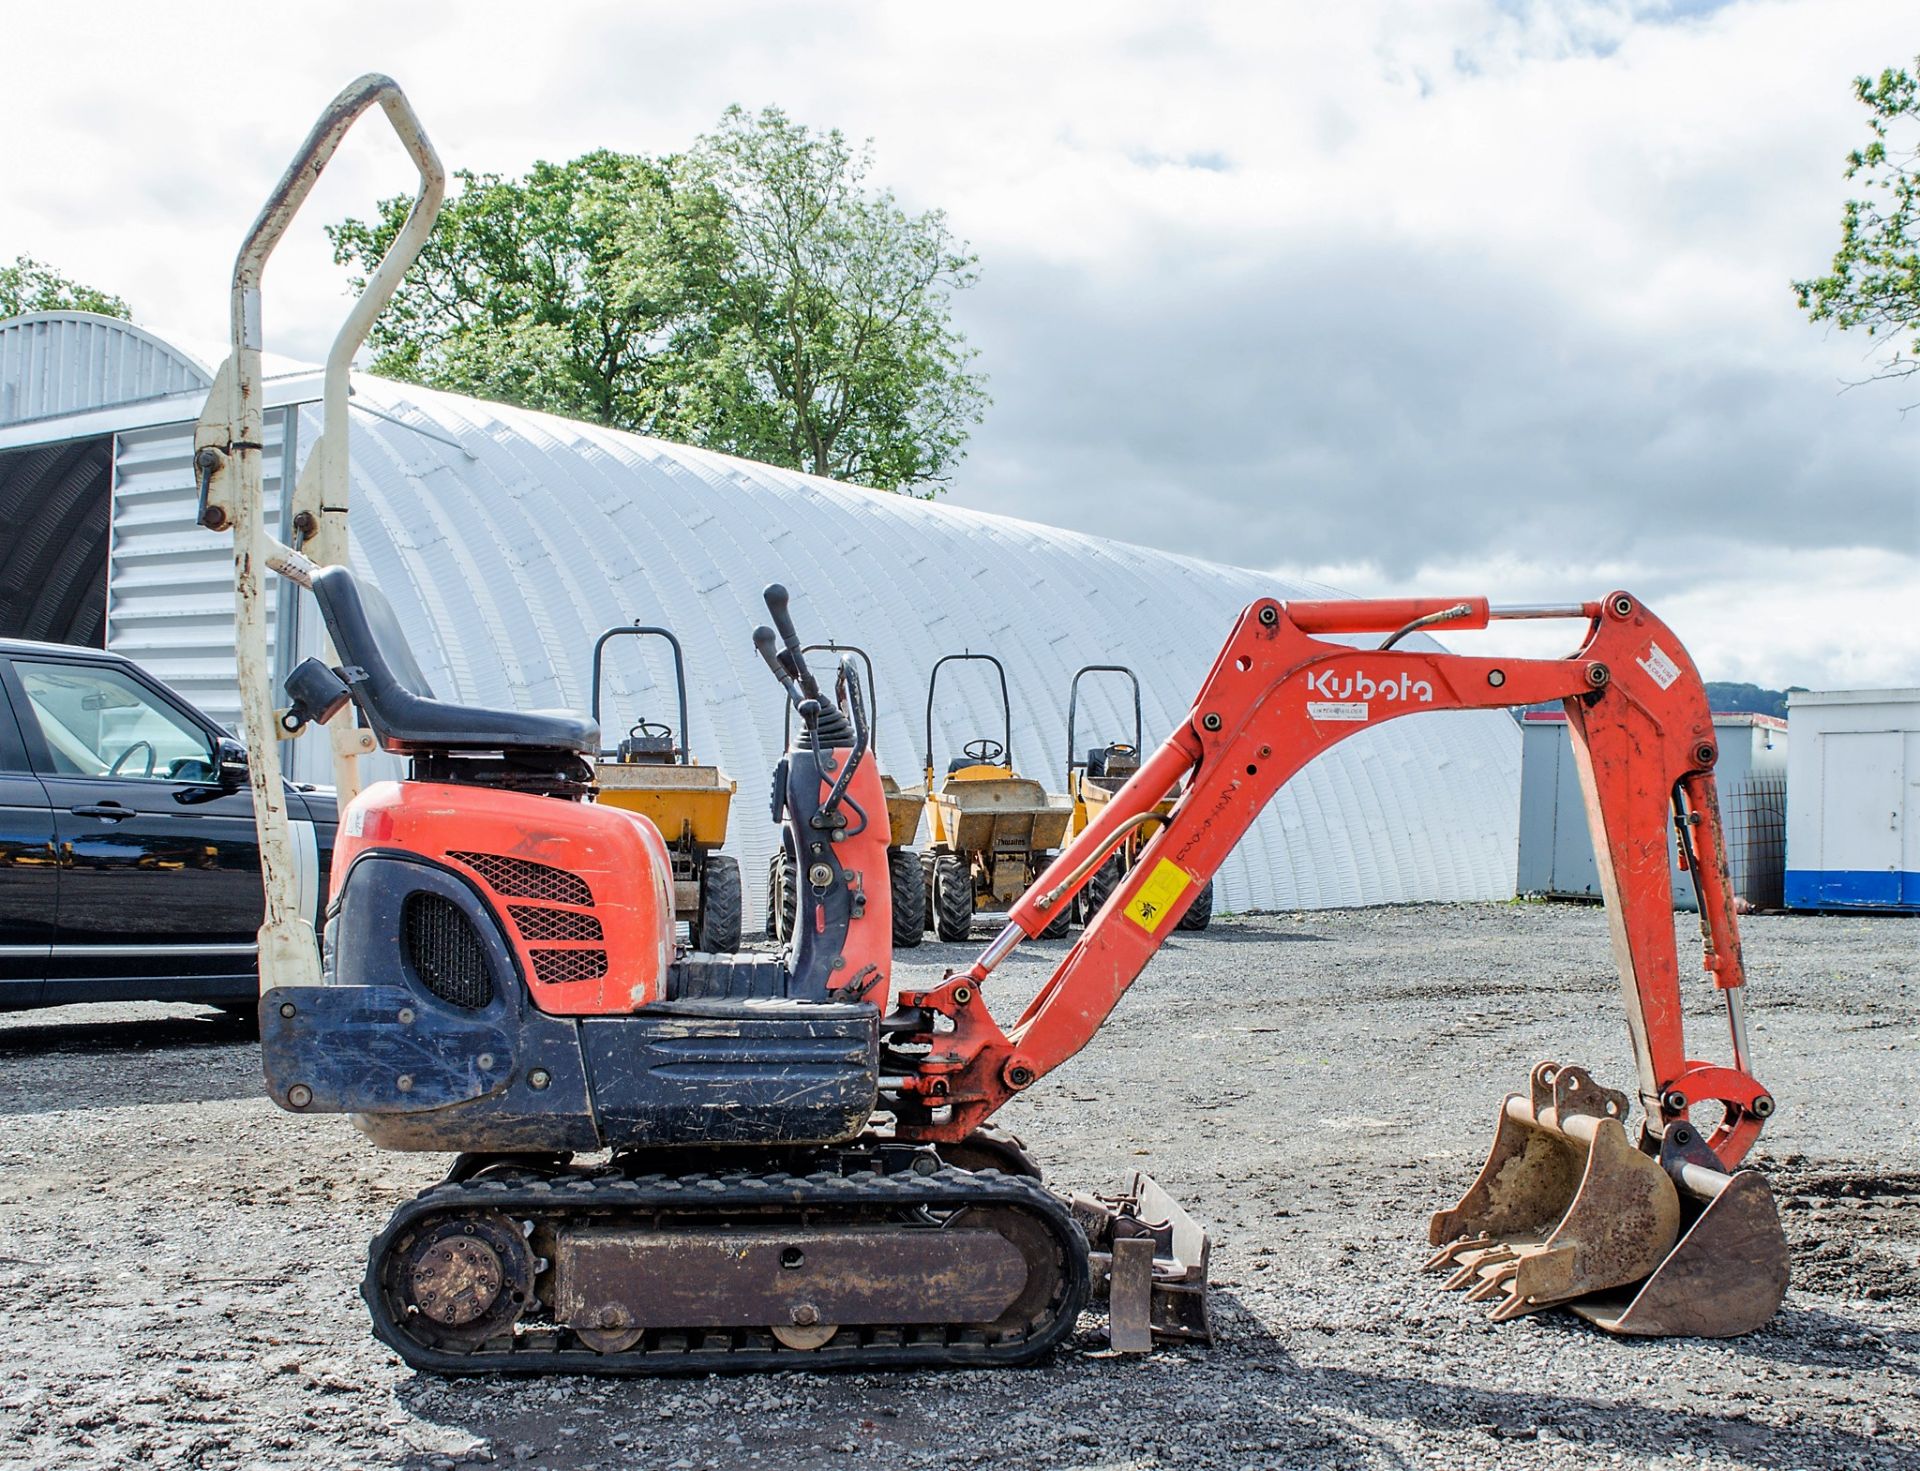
[{"xmin": 1427, "ymin": 1062, "xmax": 1680, "ymax": 1321}]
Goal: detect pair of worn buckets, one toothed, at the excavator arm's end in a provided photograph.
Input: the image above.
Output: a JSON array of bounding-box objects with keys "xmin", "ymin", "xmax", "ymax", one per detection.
[{"xmin": 1427, "ymin": 1062, "xmax": 1788, "ymax": 1338}]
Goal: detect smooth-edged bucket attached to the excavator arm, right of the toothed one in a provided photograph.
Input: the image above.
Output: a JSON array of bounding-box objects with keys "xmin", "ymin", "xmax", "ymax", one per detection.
[{"xmin": 1572, "ymin": 1123, "xmax": 1789, "ymax": 1338}]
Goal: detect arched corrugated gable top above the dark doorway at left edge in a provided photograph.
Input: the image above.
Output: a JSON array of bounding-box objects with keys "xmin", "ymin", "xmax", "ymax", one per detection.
[{"xmin": 0, "ymin": 311, "xmax": 211, "ymax": 424}]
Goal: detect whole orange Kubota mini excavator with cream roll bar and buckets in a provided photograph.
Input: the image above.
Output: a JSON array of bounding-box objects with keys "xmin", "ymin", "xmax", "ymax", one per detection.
[{"xmin": 196, "ymin": 79, "xmax": 1786, "ymax": 1373}]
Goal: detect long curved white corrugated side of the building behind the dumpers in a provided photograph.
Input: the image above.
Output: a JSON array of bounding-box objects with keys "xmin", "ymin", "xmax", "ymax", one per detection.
[{"xmin": 300, "ymin": 378, "xmax": 1521, "ymax": 929}]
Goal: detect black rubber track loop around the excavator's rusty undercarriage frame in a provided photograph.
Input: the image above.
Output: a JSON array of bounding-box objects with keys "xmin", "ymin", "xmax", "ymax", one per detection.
[{"xmin": 361, "ymin": 1168, "xmax": 1089, "ymax": 1375}]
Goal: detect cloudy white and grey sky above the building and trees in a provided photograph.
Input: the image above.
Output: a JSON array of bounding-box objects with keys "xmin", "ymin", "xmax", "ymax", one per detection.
[{"xmin": 0, "ymin": 0, "xmax": 1920, "ymax": 687}]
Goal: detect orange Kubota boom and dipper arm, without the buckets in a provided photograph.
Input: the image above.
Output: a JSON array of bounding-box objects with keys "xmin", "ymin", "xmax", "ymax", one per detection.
[{"xmin": 889, "ymin": 591, "xmax": 1772, "ymax": 1168}]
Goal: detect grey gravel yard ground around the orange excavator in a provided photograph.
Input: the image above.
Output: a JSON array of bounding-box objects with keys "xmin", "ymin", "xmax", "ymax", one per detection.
[{"xmin": 0, "ymin": 904, "xmax": 1920, "ymax": 1471}]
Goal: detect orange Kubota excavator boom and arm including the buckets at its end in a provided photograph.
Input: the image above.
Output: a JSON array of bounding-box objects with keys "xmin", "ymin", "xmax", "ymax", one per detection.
[{"xmin": 895, "ymin": 591, "xmax": 1786, "ymax": 1335}]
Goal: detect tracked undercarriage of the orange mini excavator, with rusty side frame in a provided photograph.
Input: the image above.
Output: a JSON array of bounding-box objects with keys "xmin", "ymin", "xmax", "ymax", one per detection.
[{"xmin": 361, "ymin": 1145, "xmax": 1089, "ymax": 1373}]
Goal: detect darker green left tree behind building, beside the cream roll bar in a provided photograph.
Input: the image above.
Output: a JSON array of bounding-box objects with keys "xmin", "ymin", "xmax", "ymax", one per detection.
[{"xmin": 326, "ymin": 150, "xmax": 726, "ymax": 436}]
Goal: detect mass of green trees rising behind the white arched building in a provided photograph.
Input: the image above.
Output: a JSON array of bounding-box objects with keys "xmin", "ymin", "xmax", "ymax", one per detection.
[{"xmin": 328, "ymin": 108, "xmax": 987, "ymax": 494}]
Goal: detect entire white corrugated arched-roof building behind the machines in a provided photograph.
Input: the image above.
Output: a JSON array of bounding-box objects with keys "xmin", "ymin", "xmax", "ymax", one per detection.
[{"xmin": 0, "ymin": 313, "xmax": 1521, "ymax": 920}]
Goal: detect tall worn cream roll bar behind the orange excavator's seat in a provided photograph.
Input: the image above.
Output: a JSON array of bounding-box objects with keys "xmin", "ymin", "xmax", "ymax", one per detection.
[{"xmin": 194, "ymin": 73, "xmax": 447, "ymax": 993}]
